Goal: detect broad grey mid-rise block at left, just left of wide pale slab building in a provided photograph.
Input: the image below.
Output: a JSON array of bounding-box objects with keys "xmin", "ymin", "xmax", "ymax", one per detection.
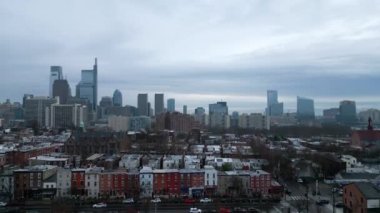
[{"xmin": 24, "ymin": 97, "xmax": 58, "ymax": 127}]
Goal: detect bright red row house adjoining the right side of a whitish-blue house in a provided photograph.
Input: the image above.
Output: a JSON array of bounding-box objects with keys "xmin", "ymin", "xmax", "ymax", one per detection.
[{"xmin": 153, "ymin": 169, "xmax": 181, "ymax": 197}]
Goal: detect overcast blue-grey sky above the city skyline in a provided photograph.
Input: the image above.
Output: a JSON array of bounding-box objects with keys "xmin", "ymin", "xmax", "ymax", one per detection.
[{"xmin": 0, "ymin": 0, "xmax": 380, "ymax": 115}]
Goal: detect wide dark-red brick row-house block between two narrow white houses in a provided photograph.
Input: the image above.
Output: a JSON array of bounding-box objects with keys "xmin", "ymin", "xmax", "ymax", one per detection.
[{"xmin": 99, "ymin": 170, "xmax": 140, "ymax": 198}]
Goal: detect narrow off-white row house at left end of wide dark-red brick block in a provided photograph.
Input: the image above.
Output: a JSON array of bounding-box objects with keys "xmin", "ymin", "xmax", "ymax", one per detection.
[{"xmin": 85, "ymin": 167, "xmax": 104, "ymax": 198}]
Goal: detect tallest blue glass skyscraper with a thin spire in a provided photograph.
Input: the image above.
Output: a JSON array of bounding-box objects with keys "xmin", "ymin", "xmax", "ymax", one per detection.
[{"xmin": 76, "ymin": 58, "xmax": 98, "ymax": 110}]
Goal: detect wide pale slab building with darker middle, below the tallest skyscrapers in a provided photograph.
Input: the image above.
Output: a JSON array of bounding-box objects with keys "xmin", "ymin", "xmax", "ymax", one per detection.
[{"xmin": 47, "ymin": 104, "xmax": 87, "ymax": 128}]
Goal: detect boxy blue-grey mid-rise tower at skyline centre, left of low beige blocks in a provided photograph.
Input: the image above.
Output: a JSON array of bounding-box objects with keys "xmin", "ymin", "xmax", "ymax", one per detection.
[{"xmin": 209, "ymin": 102, "xmax": 230, "ymax": 129}]
